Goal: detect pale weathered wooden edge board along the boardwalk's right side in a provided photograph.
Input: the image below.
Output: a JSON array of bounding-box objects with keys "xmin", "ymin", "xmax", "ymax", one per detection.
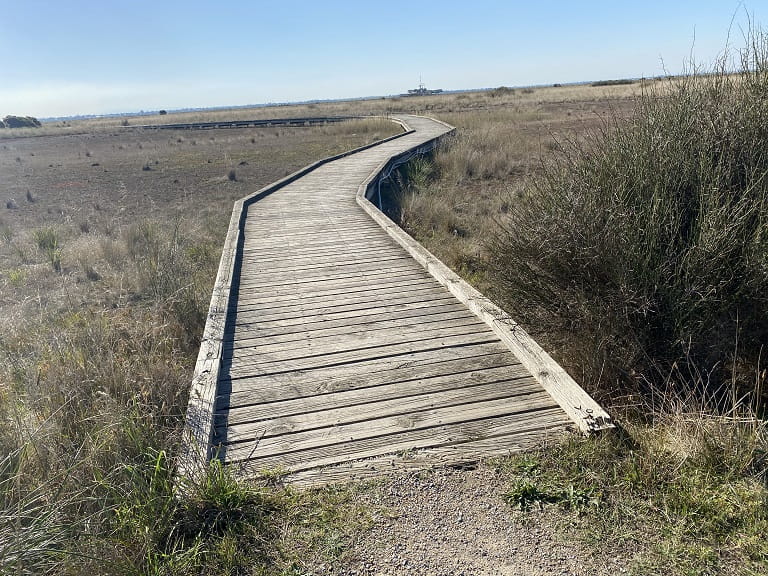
[{"xmin": 357, "ymin": 115, "xmax": 614, "ymax": 434}]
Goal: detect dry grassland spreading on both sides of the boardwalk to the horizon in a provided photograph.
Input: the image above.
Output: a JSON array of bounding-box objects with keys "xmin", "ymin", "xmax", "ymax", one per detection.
[{"xmin": 0, "ymin": 73, "xmax": 768, "ymax": 575}]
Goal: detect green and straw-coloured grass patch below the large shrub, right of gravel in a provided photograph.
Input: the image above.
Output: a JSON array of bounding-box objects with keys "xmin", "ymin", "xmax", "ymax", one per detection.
[{"xmin": 499, "ymin": 414, "xmax": 768, "ymax": 575}]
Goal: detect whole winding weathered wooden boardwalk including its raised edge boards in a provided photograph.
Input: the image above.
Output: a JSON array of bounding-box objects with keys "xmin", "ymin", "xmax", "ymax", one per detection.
[{"xmin": 182, "ymin": 116, "xmax": 610, "ymax": 482}]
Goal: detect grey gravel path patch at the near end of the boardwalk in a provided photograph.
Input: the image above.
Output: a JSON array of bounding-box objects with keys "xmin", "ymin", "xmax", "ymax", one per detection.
[{"xmin": 334, "ymin": 466, "xmax": 623, "ymax": 576}]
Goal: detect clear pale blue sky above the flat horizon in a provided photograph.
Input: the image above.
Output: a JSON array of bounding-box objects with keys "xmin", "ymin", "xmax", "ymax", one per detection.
[{"xmin": 0, "ymin": 0, "xmax": 768, "ymax": 117}]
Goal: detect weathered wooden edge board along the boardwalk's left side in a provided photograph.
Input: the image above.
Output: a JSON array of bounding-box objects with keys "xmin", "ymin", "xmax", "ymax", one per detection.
[{"xmin": 177, "ymin": 118, "xmax": 414, "ymax": 480}]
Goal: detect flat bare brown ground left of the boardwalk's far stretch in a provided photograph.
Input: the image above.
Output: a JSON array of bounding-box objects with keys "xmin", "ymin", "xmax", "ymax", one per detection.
[{"xmin": 0, "ymin": 122, "xmax": 384, "ymax": 231}]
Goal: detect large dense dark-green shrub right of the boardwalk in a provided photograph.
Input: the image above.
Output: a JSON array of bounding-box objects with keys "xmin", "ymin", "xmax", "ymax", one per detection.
[{"xmin": 491, "ymin": 29, "xmax": 768, "ymax": 402}]
